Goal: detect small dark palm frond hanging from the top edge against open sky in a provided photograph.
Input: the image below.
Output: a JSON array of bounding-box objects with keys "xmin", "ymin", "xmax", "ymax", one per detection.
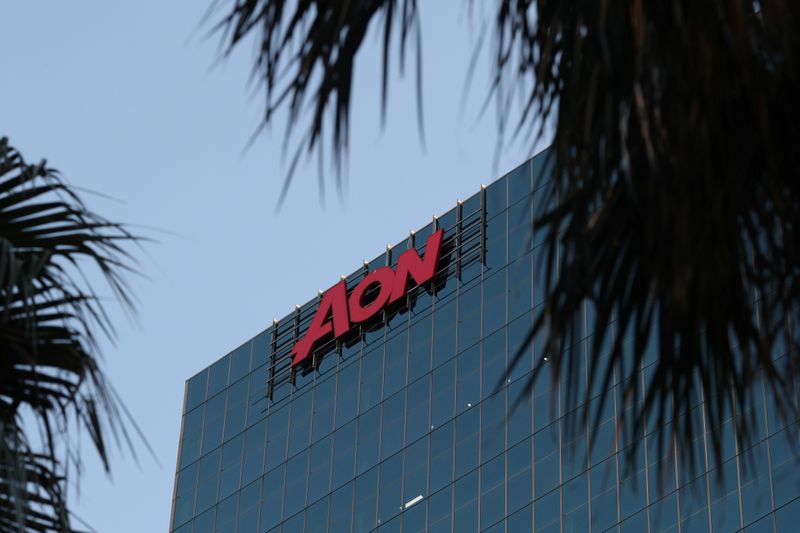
[{"xmin": 216, "ymin": 0, "xmax": 423, "ymax": 202}]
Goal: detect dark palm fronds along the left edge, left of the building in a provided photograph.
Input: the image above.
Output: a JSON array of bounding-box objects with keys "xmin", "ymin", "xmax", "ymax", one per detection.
[{"xmin": 0, "ymin": 138, "xmax": 135, "ymax": 532}]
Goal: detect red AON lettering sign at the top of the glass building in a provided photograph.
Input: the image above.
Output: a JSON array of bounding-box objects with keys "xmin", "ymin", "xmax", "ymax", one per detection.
[{"xmin": 292, "ymin": 230, "xmax": 444, "ymax": 366}]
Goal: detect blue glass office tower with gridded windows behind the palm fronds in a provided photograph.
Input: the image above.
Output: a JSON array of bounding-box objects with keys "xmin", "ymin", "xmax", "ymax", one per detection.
[{"xmin": 170, "ymin": 150, "xmax": 800, "ymax": 533}]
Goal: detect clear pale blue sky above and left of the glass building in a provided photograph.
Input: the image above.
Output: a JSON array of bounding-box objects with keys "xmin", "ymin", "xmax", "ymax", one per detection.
[{"xmin": 0, "ymin": 0, "xmax": 544, "ymax": 533}]
